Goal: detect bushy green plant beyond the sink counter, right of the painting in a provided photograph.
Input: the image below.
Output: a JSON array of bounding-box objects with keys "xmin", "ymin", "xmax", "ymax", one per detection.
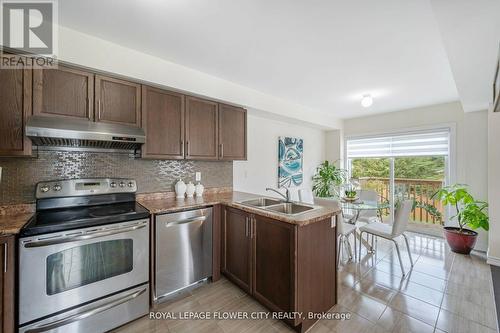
[{"xmin": 313, "ymin": 161, "xmax": 347, "ymax": 198}]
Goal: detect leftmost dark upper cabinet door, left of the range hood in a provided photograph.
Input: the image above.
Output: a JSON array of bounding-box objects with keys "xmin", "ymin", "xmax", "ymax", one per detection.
[{"xmin": 0, "ymin": 55, "xmax": 32, "ymax": 156}]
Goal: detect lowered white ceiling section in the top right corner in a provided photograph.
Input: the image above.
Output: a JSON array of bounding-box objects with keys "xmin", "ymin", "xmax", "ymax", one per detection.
[{"xmin": 432, "ymin": 0, "xmax": 500, "ymax": 111}]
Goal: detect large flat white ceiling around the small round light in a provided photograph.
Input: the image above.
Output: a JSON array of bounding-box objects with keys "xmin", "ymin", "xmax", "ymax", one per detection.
[{"xmin": 59, "ymin": 0, "xmax": 498, "ymax": 118}]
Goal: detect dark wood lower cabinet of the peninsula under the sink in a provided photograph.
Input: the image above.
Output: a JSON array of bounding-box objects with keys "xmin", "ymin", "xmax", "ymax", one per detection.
[{"xmin": 221, "ymin": 207, "xmax": 337, "ymax": 332}]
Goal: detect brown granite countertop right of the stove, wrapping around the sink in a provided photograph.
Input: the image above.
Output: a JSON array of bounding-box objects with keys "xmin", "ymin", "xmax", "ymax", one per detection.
[{"xmin": 137, "ymin": 191, "xmax": 340, "ymax": 225}]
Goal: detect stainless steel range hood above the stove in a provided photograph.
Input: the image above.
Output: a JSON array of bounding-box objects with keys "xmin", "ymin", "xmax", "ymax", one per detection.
[{"xmin": 26, "ymin": 116, "xmax": 146, "ymax": 150}]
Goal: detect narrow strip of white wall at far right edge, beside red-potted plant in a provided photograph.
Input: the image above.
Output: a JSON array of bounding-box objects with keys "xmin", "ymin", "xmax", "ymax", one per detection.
[{"xmin": 488, "ymin": 111, "xmax": 500, "ymax": 266}]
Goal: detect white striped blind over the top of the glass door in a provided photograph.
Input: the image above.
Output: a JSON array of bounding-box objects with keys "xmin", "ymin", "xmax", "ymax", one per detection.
[{"xmin": 347, "ymin": 129, "xmax": 450, "ymax": 158}]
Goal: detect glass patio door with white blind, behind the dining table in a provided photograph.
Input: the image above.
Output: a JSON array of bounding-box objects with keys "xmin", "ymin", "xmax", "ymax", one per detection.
[{"xmin": 346, "ymin": 129, "xmax": 450, "ymax": 224}]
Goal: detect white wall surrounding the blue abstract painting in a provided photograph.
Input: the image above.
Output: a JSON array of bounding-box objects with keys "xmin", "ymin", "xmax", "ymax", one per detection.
[{"xmin": 233, "ymin": 110, "xmax": 325, "ymax": 195}]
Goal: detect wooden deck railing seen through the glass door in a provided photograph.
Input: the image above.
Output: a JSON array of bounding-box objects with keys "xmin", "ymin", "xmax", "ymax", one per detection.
[{"xmin": 359, "ymin": 177, "xmax": 444, "ymax": 224}]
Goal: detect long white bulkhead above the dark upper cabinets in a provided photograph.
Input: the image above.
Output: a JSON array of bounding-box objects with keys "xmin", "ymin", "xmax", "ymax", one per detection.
[{"xmin": 58, "ymin": 27, "xmax": 341, "ymax": 129}]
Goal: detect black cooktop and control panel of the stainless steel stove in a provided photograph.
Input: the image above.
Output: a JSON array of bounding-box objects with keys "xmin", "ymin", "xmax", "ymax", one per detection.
[{"xmin": 20, "ymin": 179, "xmax": 149, "ymax": 237}]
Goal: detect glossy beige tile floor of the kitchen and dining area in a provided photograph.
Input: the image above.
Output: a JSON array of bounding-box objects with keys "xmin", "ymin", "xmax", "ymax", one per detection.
[{"xmin": 115, "ymin": 234, "xmax": 497, "ymax": 333}]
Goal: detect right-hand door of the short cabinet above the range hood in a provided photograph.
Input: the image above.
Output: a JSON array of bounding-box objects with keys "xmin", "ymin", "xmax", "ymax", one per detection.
[{"xmin": 95, "ymin": 75, "xmax": 141, "ymax": 127}]
